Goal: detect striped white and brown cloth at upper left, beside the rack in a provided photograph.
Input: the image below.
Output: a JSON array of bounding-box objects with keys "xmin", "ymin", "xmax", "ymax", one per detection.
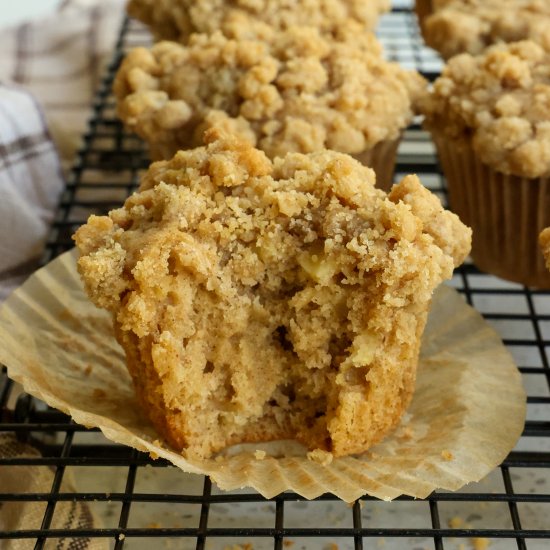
[{"xmin": 0, "ymin": 0, "xmax": 124, "ymax": 300}]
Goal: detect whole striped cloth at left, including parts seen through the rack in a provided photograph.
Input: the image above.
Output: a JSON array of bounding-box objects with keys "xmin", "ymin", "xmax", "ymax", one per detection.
[{"xmin": 0, "ymin": 0, "xmax": 123, "ymax": 550}]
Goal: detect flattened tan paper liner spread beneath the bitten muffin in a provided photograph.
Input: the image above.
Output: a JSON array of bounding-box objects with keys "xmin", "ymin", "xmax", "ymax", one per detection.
[{"xmin": 0, "ymin": 251, "xmax": 526, "ymax": 502}]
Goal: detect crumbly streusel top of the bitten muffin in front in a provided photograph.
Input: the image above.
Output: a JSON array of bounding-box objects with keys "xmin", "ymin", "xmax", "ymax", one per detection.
[{"xmin": 75, "ymin": 129, "xmax": 471, "ymax": 336}]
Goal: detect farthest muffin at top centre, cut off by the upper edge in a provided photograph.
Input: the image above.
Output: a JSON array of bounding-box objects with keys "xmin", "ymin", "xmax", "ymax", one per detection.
[{"xmin": 128, "ymin": 0, "xmax": 390, "ymax": 44}]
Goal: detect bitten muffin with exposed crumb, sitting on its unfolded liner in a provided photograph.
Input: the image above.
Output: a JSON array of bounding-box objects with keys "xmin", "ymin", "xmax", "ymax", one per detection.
[{"xmin": 75, "ymin": 129, "xmax": 470, "ymax": 459}]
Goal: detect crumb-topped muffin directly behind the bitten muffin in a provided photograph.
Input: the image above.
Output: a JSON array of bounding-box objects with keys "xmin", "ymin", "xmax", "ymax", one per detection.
[{"xmin": 114, "ymin": 27, "xmax": 425, "ymax": 189}]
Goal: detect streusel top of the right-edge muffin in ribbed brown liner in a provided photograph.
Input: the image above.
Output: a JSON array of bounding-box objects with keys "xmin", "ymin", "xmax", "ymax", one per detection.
[{"xmin": 420, "ymin": 41, "xmax": 550, "ymax": 178}]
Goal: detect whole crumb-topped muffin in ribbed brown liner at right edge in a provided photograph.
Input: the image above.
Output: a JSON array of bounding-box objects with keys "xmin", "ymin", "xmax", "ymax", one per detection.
[{"xmin": 421, "ymin": 41, "xmax": 550, "ymax": 288}]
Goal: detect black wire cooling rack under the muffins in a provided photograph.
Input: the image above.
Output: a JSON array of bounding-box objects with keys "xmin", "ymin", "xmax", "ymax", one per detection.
[{"xmin": 0, "ymin": 2, "xmax": 550, "ymax": 550}]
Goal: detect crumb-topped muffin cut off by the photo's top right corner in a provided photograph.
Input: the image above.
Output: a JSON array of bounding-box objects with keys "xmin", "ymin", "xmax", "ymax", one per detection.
[{"xmin": 424, "ymin": 0, "xmax": 550, "ymax": 58}]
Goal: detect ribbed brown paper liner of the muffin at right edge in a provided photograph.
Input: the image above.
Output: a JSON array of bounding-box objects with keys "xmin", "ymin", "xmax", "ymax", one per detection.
[{"xmin": 433, "ymin": 135, "xmax": 550, "ymax": 288}]
